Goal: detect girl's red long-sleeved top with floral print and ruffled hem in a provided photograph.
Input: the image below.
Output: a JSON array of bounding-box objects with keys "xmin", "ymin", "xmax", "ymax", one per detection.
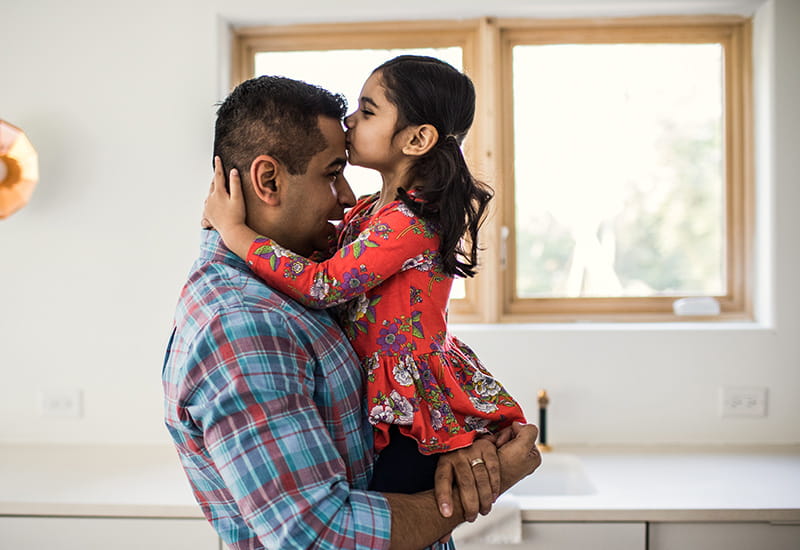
[{"xmin": 247, "ymin": 195, "xmax": 525, "ymax": 454}]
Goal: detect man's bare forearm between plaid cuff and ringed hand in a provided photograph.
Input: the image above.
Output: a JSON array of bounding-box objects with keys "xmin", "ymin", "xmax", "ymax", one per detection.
[{"xmin": 383, "ymin": 491, "xmax": 464, "ymax": 550}]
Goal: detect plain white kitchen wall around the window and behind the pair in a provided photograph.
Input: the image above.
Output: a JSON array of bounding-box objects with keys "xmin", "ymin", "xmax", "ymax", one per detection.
[{"xmin": 0, "ymin": 0, "xmax": 800, "ymax": 443}]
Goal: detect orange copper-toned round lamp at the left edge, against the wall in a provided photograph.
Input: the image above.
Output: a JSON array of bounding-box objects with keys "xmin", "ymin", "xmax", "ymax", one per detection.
[{"xmin": 0, "ymin": 120, "xmax": 39, "ymax": 219}]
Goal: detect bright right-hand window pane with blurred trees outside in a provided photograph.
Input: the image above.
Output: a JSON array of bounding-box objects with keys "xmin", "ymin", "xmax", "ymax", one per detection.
[{"xmin": 513, "ymin": 44, "xmax": 726, "ymax": 298}]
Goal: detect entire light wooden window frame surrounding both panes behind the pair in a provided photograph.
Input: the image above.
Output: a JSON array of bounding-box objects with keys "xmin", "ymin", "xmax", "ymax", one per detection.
[{"xmin": 231, "ymin": 16, "xmax": 754, "ymax": 323}]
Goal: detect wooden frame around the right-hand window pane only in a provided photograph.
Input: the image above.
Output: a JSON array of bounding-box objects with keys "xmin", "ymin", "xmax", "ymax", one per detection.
[{"xmin": 498, "ymin": 16, "xmax": 753, "ymax": 322}]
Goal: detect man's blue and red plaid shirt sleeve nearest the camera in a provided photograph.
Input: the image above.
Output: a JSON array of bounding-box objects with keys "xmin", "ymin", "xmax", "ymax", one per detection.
[{"xmin": 187, "ymin": 312, "xmax": 391, "ymax": 550}]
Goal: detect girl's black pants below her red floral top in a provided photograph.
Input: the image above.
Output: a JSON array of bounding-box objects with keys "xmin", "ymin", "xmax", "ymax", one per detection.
[{"xmin": 369, "ymin": 425, "xmax": 439, "ymax": 495}]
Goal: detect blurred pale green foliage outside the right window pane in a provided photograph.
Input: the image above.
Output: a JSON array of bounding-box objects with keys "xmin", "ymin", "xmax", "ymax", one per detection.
[{"xmin": 516, "ymin": 116, "xmax": 725, "ymax": 297}]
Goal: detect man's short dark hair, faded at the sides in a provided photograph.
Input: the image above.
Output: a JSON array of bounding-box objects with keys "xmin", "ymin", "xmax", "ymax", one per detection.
[{"xmin": 214, "ymin": 76, "xmax": 347, "ymax": 182}]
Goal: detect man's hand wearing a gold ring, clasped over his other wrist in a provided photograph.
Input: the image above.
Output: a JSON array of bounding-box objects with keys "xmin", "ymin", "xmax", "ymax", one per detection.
[{"xmin": 434, "ymin": 438, "xmax": 500, "ymax": 521}]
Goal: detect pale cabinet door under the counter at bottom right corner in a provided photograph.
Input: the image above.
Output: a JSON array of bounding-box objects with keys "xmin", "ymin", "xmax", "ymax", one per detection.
[{"xmin": 650, "ymin": 523, "xmax": 800, "ymax": 550}]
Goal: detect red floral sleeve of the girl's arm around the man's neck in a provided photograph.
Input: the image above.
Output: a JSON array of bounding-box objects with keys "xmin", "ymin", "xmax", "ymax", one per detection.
[{"xmin": 247, "ymin": 202, "xmax": 440, "ymax": 309}]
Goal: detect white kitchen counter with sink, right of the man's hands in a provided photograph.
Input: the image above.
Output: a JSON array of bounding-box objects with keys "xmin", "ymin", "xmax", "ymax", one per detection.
[{"xmin": 511, "ymin": 446, "xmax": 800, "ymax": 524}]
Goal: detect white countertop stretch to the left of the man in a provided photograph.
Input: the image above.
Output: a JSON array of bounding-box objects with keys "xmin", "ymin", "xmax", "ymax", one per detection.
[{"xmin": 0, "ymin": 445, "xmax": 203, "ymax": 518}]
